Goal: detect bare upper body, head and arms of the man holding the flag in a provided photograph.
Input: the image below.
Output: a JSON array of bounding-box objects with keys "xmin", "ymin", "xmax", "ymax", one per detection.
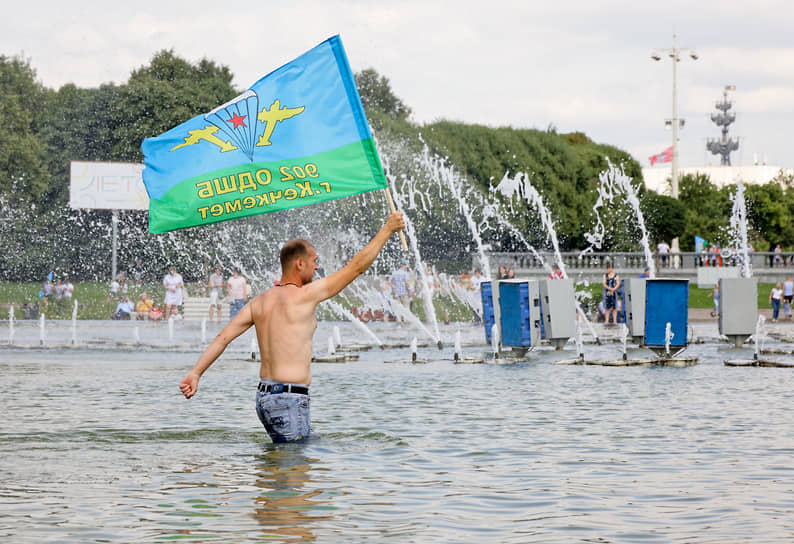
[{"xmin": 179, "ymin": 212, "xmax": 405, "ymax": 398}]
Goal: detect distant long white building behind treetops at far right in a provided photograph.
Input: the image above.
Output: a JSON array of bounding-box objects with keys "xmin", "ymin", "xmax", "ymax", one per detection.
[{"xmin": 642, "ymin": 164, "xmax": 794, "ymax": 195}]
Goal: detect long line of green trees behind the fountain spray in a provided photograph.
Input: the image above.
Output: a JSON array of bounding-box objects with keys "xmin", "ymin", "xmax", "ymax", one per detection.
[{"xmin": 6, "ymin": 51, "xmax": 794, "ymax": 281}]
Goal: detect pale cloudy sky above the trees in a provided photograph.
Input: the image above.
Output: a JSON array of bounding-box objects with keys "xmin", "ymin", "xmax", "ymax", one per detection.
[{"xmin": 0, "ymin": 0, "xmax": 794, "ymax": 168}]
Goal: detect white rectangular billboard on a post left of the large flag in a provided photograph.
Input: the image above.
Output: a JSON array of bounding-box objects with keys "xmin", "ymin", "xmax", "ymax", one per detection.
[{"xmin": 69, "ymin": 161, "xmax": 149, "ymax": 210}]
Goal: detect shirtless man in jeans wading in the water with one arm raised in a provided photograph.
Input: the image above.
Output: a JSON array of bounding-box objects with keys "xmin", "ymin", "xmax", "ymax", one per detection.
[{"xmin": 179, "ymin": 212, "xmax": 405, "ymax": 442}]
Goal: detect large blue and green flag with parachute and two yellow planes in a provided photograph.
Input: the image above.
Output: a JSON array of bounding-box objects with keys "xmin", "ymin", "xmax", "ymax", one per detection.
[{"xmin": 141, "ymin": 36, "xmax": 387, "ymax": 233}]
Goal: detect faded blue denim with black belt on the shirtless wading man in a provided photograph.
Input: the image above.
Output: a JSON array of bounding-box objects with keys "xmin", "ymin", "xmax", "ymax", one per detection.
[{"xmin": 256, "ymin": 379, "xmax": 311, "ymax": 442}]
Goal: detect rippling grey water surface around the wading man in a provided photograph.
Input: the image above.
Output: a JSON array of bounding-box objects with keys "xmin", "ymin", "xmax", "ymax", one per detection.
[{"xmin": 0, "ymin": 324, "xmax": 794, "ymax": 543}]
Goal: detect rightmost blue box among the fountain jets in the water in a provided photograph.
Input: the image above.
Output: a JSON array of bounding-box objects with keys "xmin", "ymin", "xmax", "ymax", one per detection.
[{"xmin": 644, "ymin": 279, "xmax": 689, "ymax": 347}]
